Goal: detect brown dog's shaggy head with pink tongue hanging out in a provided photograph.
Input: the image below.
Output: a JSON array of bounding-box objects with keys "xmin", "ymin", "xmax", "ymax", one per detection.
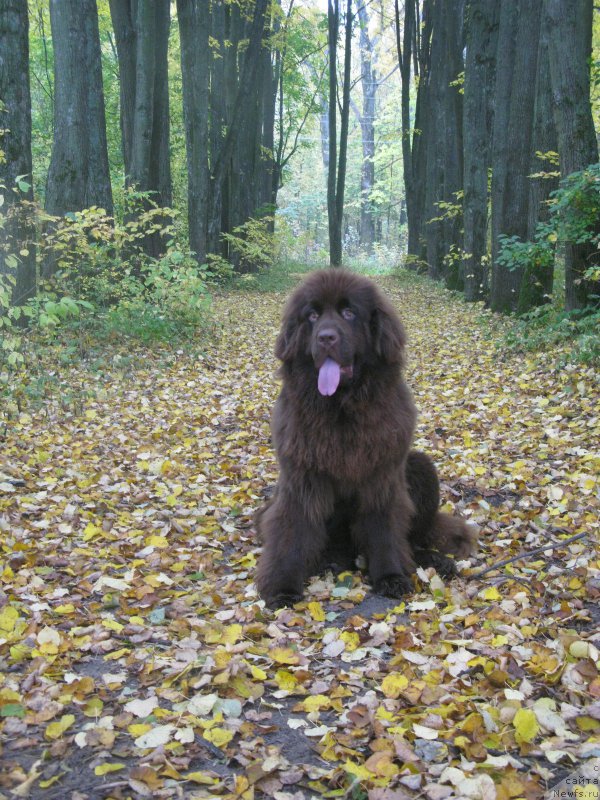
[{"xmin": 275, "ymin": 269, "xmax": 405, "ymax": 396}]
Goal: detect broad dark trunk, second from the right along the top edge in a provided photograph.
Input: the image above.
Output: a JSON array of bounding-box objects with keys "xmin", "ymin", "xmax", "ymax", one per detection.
[{"xmin": 490, "ymin": 0, "xmax": 542, "ymax": 312}]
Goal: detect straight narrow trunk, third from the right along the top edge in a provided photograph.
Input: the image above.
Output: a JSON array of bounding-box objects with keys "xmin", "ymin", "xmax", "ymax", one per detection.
[{"xmin": 462, "ymin": 0, "xmax": 499, "ymax": 301}]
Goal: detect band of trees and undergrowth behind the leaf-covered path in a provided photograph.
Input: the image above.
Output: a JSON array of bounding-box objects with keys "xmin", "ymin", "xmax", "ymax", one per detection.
[{"xmin": 0, "ymin": 0, "xmax": 600, "ymax": 350}]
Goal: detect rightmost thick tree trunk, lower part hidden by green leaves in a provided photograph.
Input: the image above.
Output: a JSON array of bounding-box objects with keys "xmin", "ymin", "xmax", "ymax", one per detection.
[{"xmin": 544, "ymin": 0, "xmax": 600, "ymax": 310}]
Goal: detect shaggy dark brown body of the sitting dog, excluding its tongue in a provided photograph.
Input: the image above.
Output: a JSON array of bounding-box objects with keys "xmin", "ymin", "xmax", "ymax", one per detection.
[{"xmin": 257, "ymin": 269, "xmax": 474, "ymax": 607}]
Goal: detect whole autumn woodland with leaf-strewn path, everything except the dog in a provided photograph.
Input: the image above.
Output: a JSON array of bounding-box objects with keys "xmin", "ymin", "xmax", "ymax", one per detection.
[{"xmin": 0, "ymin": 0, "xmax": 600, "ymax": 800}]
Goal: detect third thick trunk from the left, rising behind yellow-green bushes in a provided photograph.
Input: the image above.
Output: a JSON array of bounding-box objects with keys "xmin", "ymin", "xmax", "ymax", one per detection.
[{"xmin": 110, "ymin": 0, "xmax": 172, "ymax": 257}]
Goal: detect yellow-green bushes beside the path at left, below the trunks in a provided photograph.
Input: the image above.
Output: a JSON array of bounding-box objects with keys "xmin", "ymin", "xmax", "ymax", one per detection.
[{"xmin": 0, "ymin": 184, "xmax": 215, "ymax": 412}]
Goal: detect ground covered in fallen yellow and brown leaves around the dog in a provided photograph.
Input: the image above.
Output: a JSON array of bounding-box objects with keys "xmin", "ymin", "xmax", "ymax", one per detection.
[{"xmin": 0, "ymin": 281, "xmax": 600, "ymax": 800}]
